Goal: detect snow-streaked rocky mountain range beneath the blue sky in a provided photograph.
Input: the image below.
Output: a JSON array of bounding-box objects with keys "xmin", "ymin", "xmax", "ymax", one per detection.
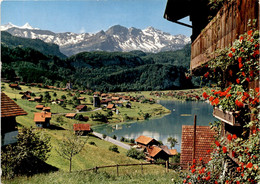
[{"xmin": 1, "ymin": 24, "xmax": 190, "ymax": 56}]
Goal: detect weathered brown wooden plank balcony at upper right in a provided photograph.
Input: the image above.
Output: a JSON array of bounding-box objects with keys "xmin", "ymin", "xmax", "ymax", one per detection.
[{"xmin": 190, "ymin": 0, "xmax": 259, "ymax": 73}]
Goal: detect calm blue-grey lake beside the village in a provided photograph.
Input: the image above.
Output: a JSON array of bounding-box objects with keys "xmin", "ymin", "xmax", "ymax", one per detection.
[{"xmin": 93, "ymin": 101, "xmax": 217, "ymax": 152}]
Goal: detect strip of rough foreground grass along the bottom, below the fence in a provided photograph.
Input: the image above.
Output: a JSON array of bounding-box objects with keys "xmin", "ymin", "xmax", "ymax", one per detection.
[{"xmin": 4, "ymin": 170, "xmax": 182, "ymax": 184}]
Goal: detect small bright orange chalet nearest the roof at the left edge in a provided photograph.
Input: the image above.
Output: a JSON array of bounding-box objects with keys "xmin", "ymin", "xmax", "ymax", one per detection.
[{"xmin": 33, "ymin": 111, "xmax": 51, "ymax": 128}]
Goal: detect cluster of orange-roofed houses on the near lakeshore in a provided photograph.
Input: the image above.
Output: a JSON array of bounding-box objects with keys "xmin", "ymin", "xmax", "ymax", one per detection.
[{"xmin": 135, "ymin": 135, "xmax": 178, "ymax": 162}]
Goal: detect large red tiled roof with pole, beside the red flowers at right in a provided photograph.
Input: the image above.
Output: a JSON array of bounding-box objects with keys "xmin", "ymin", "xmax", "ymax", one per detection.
[{"xmin": 180, "ymin": 125, "xmax": 216, "ymax": 169}]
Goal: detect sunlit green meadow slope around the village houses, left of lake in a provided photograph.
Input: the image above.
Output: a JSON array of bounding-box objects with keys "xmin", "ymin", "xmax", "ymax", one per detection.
[{"xmin": 2, "ymin": 83, "xmax": 182, "ymax": 183}]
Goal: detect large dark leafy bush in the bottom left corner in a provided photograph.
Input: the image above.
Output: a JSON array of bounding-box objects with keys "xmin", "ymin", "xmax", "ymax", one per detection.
[{"xmin": 1, "ymin": 128, "xmax": 51, "ymax": 177}]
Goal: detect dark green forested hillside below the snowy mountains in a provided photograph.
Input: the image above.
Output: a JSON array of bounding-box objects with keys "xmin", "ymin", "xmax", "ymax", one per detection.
[{"xmin": 1, "ymin": 33, "xmax": 193, "ymax": 92}]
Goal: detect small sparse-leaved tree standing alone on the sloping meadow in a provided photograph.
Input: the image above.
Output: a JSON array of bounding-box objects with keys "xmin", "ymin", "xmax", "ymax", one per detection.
[{"xmin": 56, "ymin": 132, "xmax": 88, "ymax": 172}]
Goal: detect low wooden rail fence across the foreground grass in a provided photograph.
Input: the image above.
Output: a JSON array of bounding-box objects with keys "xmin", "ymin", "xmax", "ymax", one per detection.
[{"xmin": 83, "ymin": 161, "xmax": 180, "ymax": 176}]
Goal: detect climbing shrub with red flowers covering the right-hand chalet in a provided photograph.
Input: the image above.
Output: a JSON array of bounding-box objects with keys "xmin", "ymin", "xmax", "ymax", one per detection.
[{"xmin": 183, "ymin": 25, "xmax": 260, "ymax": 184}]
